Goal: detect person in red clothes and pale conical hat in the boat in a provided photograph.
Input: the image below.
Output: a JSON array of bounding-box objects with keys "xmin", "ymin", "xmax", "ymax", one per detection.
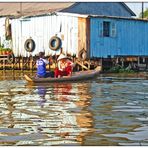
[{"xmin": 54, "ymin": 54, "xmax": 75, "ymax": 78}]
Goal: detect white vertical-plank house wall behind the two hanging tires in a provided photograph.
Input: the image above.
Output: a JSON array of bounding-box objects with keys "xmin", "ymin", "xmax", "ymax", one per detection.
[{"xmin": 11, "ymin": 15, "xmax": 78, "ymax": 57}]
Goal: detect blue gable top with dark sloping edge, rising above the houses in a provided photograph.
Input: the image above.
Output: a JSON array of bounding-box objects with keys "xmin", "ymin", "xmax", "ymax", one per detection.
[{"xmin": 61, "ymin": 2, "xmax": 135, "ymax": 17}]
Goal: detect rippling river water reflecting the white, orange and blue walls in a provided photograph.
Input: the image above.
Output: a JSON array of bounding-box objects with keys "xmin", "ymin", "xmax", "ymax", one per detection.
[{"xmin": 0, "ymin": 72, "xmax": 148, "ymax": 146}]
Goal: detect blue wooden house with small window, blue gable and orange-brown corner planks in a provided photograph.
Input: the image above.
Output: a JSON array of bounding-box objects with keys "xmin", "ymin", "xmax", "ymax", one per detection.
[{"xmin": 62, "ymin": 2, "xmax": 148, "ymax": 66}]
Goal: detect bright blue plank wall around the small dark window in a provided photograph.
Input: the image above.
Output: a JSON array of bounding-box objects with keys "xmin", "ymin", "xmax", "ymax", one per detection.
[{"xmin": 90, "ymin": 18, "xmax": 148, "ymax": 58}]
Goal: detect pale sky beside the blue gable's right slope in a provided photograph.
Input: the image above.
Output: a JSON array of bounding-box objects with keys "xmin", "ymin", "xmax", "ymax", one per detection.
[{"xmin": 125, "ymin": 2, "xmax": 148, "ymax": 16}]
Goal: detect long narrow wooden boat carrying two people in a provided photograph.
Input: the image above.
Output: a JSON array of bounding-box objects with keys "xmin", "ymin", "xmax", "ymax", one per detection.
[{"xmin": 24, "ymin": 66, "xmax": 101, "ymax": 83}]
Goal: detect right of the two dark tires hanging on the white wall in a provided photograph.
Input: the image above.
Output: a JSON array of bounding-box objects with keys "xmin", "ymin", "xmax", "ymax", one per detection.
[{"xmin": 49, "ymin": 36, "xmax": 61, "ymax": 50}]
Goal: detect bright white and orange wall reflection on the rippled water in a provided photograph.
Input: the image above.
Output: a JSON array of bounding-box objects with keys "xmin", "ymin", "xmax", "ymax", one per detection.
[{"xmin": 0, "ymin": 81, "xmax": 93, "ymax": 145}]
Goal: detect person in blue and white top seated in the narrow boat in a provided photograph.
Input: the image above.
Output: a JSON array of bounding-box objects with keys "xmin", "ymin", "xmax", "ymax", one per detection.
[{"xmin": 36, "ymin": 52, "xmax": 54, "ymax": 78}]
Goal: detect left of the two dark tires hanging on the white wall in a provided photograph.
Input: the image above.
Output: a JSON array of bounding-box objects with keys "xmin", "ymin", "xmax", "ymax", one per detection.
[{"xmin": 24, "ymin": 39, "xmax": 35, "ymax": 52}]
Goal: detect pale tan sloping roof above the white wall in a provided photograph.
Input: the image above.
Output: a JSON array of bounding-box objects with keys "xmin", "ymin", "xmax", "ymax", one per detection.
[{"xmin": 0, "ymin": 2, "xmax": 74, "ymax": 18}]
